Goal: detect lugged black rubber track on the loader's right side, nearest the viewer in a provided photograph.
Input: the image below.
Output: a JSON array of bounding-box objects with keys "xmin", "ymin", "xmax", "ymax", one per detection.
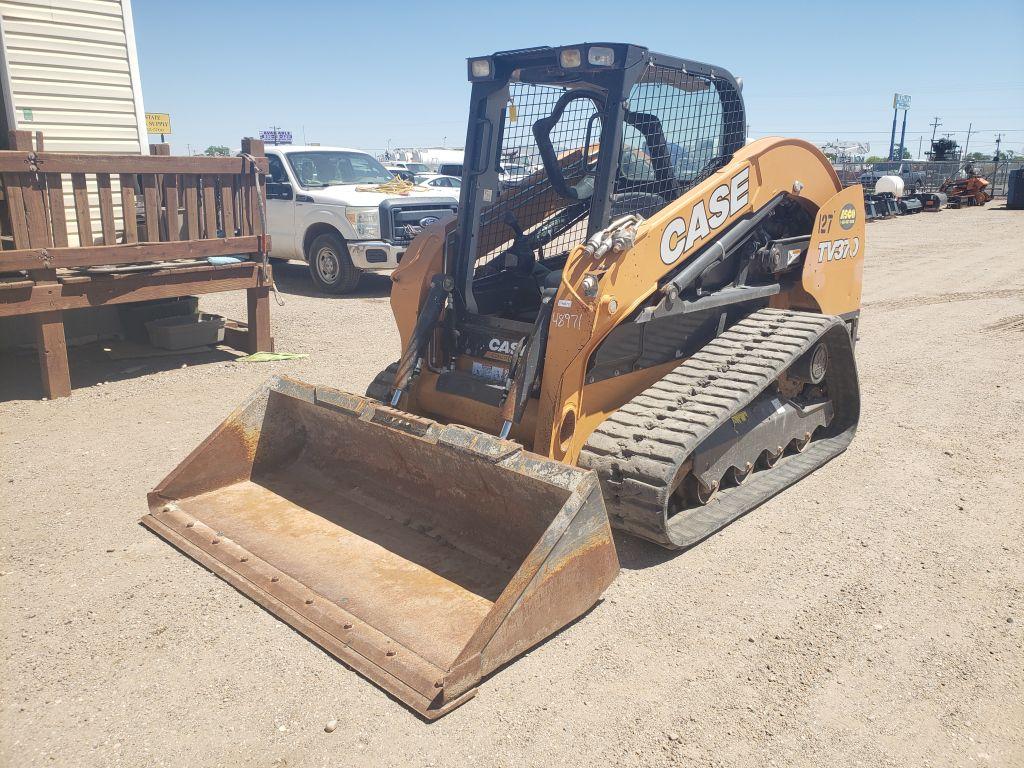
[{"xmin": 580, "ymin": 309, "xmax": 859, "ymax": 549}]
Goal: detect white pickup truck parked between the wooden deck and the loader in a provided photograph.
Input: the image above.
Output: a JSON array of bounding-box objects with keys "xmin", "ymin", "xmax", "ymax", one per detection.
[{"xmin": 266, "ymin": 146, "xmax": 459, "ymax": 294}]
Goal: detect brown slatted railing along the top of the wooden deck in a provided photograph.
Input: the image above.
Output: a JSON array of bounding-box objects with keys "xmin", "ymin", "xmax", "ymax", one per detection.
[{"xmin": 0, "ymin": 131, "xmax": 267, "ymax": 271}]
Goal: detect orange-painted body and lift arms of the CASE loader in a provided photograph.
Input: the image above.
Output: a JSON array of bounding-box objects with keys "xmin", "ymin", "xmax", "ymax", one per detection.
[{"xmin": 391, "ymin": 138, "xmax": 865, "ymax": 464}]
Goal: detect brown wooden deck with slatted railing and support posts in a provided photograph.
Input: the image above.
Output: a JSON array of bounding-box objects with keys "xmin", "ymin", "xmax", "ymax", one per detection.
[{"xmin": 0, "ymin": 131, "xmax": 273, "ymax": 398}]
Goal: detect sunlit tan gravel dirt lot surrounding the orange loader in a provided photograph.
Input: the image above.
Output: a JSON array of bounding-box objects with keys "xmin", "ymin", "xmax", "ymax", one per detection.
[{"xmin": 0, "ymin": 206, "xmax": 1024, "ymax": 768}]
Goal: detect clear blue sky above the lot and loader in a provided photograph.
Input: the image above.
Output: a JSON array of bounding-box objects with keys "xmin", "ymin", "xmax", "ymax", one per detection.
[{"xmin": 133, "ymin": 0, "xmax": 1024, "ymax": 154}]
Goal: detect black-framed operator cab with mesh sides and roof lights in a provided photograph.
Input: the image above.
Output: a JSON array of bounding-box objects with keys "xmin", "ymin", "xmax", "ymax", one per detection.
[{"xmin": 454, "ymin": 43, "xmax": 745, "ymax": 323}]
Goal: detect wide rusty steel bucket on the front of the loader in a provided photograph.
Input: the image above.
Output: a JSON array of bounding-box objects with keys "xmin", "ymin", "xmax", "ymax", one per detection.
[{"xmin": 142, "ymin": 377, "xmax": 618, "ymax": 719}]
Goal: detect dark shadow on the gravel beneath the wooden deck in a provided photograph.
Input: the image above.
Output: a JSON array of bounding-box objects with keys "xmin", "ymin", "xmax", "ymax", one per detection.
[{"xmin": 0, "ymin": 342, "xmax": 241, "ymax": 402}]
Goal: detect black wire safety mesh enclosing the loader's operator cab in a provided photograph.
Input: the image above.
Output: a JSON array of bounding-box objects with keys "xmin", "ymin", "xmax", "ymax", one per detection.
[{"xmin": 468, "ymin": 63, "xmax": 743, "ymax": 276}]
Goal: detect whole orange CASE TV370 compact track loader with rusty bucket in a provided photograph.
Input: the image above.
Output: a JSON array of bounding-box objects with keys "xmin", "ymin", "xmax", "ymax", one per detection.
[{"xmin": 143, "ymin": 43, "xmax": 864, "ymax": 718}]
